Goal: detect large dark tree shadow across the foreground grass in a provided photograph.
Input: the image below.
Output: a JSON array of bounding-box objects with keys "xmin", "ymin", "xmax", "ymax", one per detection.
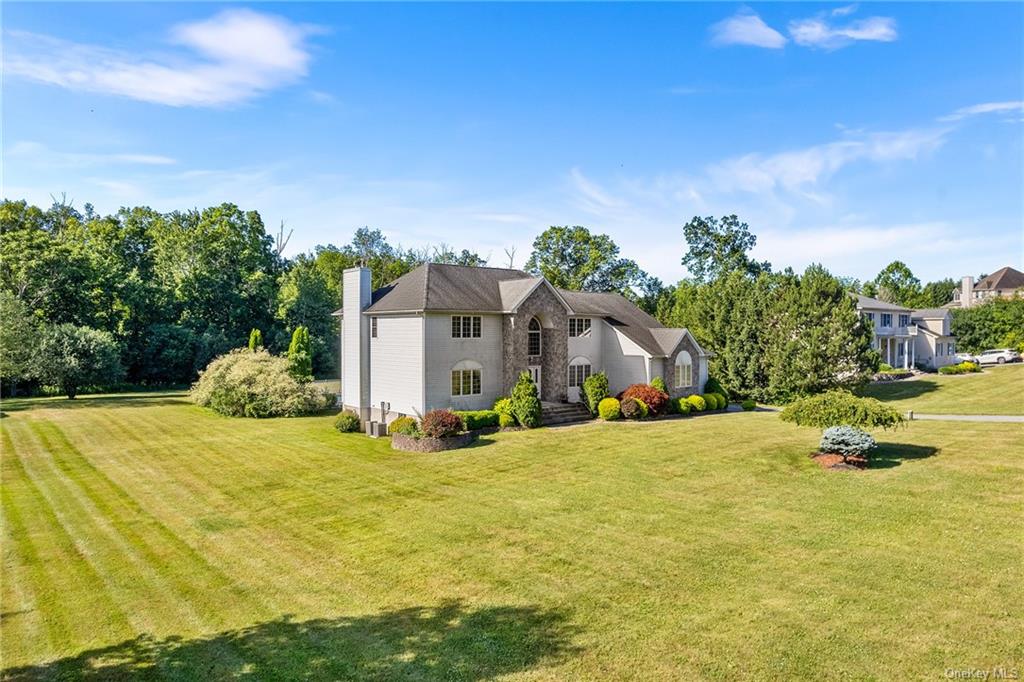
[{"xmin": 0, "ymin": 601, "xmax": 577, "ymax": 681}]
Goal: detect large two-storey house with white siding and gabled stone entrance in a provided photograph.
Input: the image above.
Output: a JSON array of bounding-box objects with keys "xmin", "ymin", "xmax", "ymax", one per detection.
[{"xmin": 335, "ymin": 263, "xmax": 709, "ymax": 421}]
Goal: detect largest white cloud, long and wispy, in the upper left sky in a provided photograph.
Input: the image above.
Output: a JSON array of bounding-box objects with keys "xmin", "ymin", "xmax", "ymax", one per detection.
[{"xmin": 4, "ymin": 9, "xmax": 315, "ymax": 106}]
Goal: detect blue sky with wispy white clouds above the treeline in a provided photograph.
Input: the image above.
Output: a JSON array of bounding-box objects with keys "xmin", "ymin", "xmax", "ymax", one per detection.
[{"xmin": 3, "ymin": 3, "xmax": 1024, "ymax": 282}]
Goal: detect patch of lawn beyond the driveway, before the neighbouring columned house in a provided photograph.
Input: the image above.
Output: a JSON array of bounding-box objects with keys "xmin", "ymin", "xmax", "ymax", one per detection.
[{"xmin": 862, "ymin": 364, "xmax": 1024, "ymax": 415}]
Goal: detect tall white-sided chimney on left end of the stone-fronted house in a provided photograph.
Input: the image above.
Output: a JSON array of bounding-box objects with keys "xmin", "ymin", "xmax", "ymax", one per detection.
[{"xmin": 341, "ymin": 267, "xmax": 373, "ymax": 421}]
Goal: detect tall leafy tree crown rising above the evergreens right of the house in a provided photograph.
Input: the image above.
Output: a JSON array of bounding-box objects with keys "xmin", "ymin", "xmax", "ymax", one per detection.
[{"xmin": 682, "ymin": 215, "xmax": 771, "ymax": 283}]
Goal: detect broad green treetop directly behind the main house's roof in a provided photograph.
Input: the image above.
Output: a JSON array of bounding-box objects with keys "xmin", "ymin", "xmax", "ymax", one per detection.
[{"xmin": 526, "ymin": 225, "xmax": 645, "ymax": 293}]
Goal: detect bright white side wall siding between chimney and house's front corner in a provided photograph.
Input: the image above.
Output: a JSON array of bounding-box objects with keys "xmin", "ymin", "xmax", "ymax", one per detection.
[{"xmin": 368, "ymin": 315, "xmax": 424, "ymax": 417}]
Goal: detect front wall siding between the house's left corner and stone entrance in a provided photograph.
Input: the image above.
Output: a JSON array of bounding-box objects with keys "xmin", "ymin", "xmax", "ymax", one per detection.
[{"xmin": 424, "ymin": 313, "xmax": 503, "ymax": 410}]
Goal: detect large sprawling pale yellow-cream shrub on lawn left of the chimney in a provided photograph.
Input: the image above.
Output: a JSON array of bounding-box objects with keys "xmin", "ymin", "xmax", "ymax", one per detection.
[{"xmin": 191, "ymin": 348, "xmax": 327, "ymax": 417}]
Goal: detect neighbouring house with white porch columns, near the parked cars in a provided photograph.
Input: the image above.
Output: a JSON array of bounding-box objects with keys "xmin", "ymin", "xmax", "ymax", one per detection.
[{"xmin": 855, "ymin": 294, "xmax": 956, "ymax": 370}]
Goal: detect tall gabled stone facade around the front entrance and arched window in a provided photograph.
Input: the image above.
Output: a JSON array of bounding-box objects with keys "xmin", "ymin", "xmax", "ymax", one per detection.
[{"xmin": 502, "ymin": 284, "xmax": 568, "ymax": 402}]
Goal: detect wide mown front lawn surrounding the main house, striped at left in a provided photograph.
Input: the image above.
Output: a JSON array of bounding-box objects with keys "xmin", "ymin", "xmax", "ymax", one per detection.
[{"xmin": 0, "ymin": 394, "xmax": 1024, "ymax": 680}]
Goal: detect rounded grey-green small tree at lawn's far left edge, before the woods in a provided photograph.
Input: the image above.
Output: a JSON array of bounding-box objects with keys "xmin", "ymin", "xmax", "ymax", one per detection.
[{"xmin": 35, "ymin": 324, "xmax": 124, "ymax": 398}]
